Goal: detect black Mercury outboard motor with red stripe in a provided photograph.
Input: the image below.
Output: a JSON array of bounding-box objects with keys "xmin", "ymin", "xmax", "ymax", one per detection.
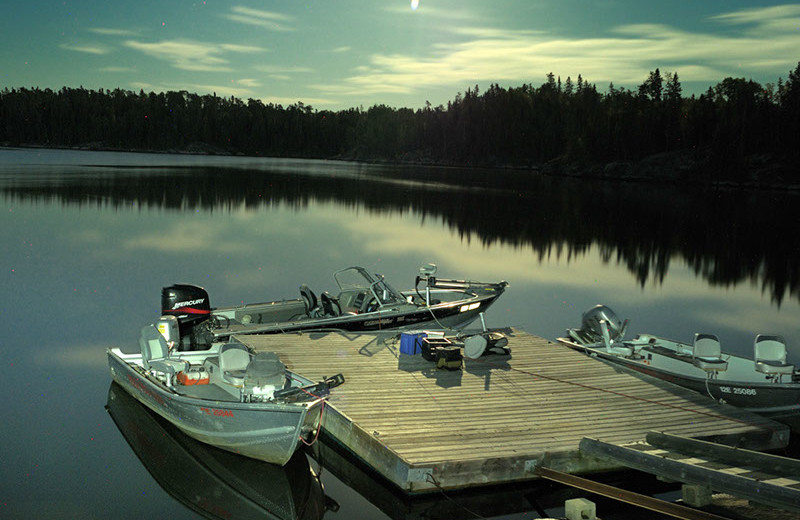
[{"xmin": 161, "ymin": 284, "xmax": 211, "ymax": 350}]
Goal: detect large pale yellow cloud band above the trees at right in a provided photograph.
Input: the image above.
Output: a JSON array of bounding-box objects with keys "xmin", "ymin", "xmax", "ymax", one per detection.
[{"xmin": 312, "ymin": 5, "xmax": 800, "ymax": 96}]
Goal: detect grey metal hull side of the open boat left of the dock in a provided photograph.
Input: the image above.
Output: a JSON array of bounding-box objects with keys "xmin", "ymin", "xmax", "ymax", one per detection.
[{"xmin": 108, "ymin": 350, "xmax": 322, "ymax": 465}]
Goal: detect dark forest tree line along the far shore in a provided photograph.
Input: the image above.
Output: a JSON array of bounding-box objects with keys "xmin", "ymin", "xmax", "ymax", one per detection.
[{"xmin": 0, "ymin": 63, "xmax": 800, "ymax": 182}]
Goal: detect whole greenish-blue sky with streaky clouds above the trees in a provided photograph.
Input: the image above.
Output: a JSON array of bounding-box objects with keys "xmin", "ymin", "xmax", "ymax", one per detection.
[{"xmin": 0, "ymin": 0, "xmax": 800, "ymax": 110}]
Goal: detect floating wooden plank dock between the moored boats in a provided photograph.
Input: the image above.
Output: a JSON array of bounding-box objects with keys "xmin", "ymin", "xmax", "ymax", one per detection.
[{"xmin": 236, "ymin": 330, "xmax": 789, "ymax": 493}]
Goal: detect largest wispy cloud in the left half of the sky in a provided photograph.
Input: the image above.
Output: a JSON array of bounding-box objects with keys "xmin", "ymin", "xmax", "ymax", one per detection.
[{"xmin": 124, "ymin": 40, "xmax": 264, "ymax": 72}]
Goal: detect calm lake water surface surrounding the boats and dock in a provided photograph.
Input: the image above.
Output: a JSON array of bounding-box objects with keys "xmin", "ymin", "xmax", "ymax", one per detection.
[{"xmin": 0, "ymin": 148, "xmax": 800, "ymax": 519}]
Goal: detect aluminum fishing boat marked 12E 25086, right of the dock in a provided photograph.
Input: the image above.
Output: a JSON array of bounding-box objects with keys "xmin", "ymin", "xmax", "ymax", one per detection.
[{"xmin": 558, "ymin": 305, "xmax": 800, "ymax": 425}]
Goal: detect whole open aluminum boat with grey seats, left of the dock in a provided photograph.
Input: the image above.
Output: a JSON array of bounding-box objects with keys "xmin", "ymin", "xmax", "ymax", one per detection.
[{"xmin": 108, "ymin": 322, "xmax": 344, "ymax": 465}]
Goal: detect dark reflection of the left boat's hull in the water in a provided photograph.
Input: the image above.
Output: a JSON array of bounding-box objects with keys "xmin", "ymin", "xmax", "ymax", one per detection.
[{"xmin": 106, "ymin": 383, "xmax": 338, "ymax": 520}]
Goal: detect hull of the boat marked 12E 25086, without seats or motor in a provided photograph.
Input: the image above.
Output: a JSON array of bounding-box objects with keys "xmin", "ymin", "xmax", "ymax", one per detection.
[{"xmin": 558, "ymin": 338, "xmax": 800, "ymax": 422}]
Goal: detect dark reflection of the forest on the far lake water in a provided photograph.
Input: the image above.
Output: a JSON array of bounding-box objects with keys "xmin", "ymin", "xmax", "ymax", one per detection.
[{"xmin": 0, "ymin": 163, "xmax": 800, "ymax": 305}]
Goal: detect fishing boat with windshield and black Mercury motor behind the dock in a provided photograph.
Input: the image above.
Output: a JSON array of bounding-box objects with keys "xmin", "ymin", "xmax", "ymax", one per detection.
[{"xmin": 161, "ymin": 264, "xmax": 508, "ymax": 350}]
